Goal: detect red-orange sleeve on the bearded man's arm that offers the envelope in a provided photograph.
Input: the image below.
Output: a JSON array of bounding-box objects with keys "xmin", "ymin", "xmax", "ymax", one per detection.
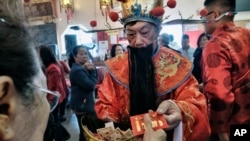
[{"xmin": 172, "ymin": 76, "xmax": 210, "ymax": 141}]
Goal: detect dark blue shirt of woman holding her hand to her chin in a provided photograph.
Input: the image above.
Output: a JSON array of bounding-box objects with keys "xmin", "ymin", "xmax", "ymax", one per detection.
[{"xmin": 70, "ymin": 63, "xmax": 97, "ymax": 114}]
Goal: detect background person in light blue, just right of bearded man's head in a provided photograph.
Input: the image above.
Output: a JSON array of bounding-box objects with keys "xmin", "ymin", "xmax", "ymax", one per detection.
[{"xmin": 178, "ymin": 34, "xmax": 195, "ymax": 62}]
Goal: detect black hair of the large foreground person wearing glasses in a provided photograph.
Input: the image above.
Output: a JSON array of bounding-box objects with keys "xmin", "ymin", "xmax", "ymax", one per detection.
[{"xmin": 0, "ymin": 1, "xmax": 40, "ymax": 102}]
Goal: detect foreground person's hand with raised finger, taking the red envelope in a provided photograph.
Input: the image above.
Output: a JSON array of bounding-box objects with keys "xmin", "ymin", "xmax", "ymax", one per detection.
[{"xmin": 143, "ymin": 114, "xmax": 167, "ymax": 141}]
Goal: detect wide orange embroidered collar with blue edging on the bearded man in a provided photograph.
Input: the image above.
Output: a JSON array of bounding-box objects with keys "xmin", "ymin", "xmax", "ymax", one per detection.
[{"xmin": 105, "ymin": 47, "xmax": 192, "ymax": 96}]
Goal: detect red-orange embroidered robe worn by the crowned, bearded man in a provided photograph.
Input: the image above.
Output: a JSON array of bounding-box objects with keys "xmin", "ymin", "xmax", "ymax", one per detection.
[{"xmin": 95, "ymin": 47, "xmax": 210, "ymax": 141}]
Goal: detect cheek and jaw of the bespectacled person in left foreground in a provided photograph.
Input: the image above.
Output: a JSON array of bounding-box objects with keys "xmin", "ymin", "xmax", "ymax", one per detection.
[{"xmin": 0, "ymin": 70, "xmax": 50, "ymax": 141}]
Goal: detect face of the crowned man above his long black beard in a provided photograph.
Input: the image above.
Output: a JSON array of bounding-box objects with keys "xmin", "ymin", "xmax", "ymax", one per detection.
[{"xmin": 125, "ymin": 21, "xmax": 158, "ymax": 48}]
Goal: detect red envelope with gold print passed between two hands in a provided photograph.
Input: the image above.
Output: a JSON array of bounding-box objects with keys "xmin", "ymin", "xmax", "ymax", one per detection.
[{"xmin": 130, "ymin": 112, "xmax": 168, "ymax": 136}]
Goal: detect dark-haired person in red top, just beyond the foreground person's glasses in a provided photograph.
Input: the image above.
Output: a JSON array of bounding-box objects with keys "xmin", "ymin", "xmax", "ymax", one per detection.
[{"xmin": 38, "ymin": 45, "xmax": 70, "ymax": 141}]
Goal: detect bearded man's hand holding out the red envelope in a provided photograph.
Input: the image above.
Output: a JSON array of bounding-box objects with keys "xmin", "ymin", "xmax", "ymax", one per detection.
[{"xmin": 156, "ymin": 100, "xmax": 182, "ymax": 130}]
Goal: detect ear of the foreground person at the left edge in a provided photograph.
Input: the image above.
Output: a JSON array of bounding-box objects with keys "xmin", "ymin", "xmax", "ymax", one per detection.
[{"xmin": 0, "ymin": 76, "xmax": 17, "ymax": 141}]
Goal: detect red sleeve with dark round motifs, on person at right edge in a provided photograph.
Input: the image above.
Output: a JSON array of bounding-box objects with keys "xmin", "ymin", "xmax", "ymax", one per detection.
[{"xmin": 202, "ymin": 41, "xmax": 235, "ymax": 133}]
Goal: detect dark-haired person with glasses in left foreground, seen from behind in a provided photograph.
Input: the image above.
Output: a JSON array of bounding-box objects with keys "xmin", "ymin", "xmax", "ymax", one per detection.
[{"xmin": 0, "ymin": 1, "xmax": 51, "ymax": 141}]
